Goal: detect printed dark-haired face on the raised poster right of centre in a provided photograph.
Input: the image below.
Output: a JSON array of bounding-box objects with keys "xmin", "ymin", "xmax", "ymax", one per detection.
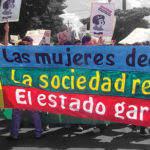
[{"xmin": 93, "ymin": 15, "xmax": 105, "ymax": 31}]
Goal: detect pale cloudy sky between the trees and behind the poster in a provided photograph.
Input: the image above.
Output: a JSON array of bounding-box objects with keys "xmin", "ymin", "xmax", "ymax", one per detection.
[{"xmin": 62, "ymin": 0, "xmax": 150, "ymax": 30}]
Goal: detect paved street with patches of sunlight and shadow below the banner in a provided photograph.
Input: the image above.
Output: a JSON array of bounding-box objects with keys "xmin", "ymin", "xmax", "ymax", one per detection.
[{"xmin": 0, "ymin": 119, "xmax": 150, "ymax": 150}]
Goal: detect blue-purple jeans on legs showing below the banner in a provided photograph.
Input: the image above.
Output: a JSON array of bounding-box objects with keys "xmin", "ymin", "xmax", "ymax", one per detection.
[{"xmin": 11, "ymin": 109, "xmax": 42, "ymax": 137}]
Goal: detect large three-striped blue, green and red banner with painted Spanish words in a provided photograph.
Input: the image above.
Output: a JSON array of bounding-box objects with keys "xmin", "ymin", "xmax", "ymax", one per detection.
[{"xmin": 0, "ymin": 46, "xmax": 150, "ymax": 127}]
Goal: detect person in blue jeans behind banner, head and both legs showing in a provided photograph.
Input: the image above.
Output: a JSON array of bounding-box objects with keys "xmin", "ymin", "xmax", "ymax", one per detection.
[{"xmin": 7, "ymin": 36, "xmax": 43, "ymax": 140}]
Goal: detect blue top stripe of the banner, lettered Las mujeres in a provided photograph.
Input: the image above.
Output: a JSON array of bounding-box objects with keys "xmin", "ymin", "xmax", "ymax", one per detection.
[{"xmin": 0, "ymin": 45, "xmax": 150, "ymax": 72}]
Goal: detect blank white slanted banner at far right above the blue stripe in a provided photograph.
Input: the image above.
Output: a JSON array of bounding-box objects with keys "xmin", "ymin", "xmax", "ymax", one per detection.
[{"xmin": 119, "ymin": 28, "xmax": 150, "ymax": 44}]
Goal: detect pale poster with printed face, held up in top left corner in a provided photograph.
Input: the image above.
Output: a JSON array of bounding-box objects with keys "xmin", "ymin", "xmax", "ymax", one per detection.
[{"xmin": 0, "ymin": 0, "xmax": 22, "ymax": 23}]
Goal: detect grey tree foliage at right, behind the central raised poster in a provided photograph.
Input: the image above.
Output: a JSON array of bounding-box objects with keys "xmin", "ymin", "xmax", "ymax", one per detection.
[{"xmin": 81, "ymin": 7, "xmax": 150, "ymax": 42}]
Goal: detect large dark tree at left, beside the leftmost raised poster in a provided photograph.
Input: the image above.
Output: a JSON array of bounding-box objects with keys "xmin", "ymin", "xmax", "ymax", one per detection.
[{"xmin": 0, "ymin": 0, "xmax": 66, "ymax": 42}]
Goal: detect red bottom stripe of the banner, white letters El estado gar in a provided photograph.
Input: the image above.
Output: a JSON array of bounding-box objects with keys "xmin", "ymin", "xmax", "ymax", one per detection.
[{"xmin": 3, "ymin": 86, "xmax": 150, "ymax": 127}]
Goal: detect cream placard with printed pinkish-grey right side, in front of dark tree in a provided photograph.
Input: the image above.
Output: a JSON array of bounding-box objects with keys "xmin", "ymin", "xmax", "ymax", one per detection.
[{"xmin": 26, "ymin": 29, "xmax": 51, "ymax": 45}]
